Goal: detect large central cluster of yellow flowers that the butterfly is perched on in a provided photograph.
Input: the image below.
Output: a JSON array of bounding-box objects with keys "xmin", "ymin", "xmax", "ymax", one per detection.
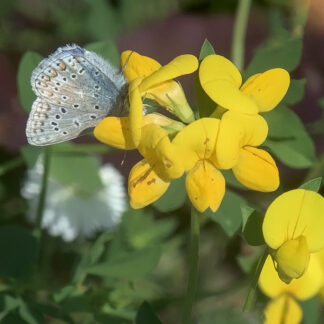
[{"xmin": 94, "ymin": 51, "xmax": 290, "ymax": 212}]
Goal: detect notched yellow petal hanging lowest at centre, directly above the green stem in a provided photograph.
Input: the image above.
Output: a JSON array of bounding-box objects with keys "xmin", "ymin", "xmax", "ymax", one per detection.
[{"xmin": 186, "ymin": 160, "xmax": 225, "ymax": 212}]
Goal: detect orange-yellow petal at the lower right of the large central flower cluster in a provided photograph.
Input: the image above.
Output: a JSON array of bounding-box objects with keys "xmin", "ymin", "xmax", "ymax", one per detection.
[{"xmin": 232, "ymin": 146, "xmax": 280, "ymax": 192}]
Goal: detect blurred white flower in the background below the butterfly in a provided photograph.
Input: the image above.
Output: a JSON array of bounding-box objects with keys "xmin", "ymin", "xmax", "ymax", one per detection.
[{"xmin": 21, "ymin": 159, "xmax": 126, "ymax": 241}]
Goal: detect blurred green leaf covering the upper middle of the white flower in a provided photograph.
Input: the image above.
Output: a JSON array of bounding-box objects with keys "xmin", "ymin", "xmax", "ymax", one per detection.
[{"xmin": 50, "ymin": 143, "xmax": 103, "ymax": 195}]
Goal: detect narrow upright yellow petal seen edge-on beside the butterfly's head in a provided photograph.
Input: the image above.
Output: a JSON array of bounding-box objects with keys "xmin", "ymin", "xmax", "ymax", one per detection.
[{"xmin": 128, "ymin": 79, "xmax": 143, "ymax": 147}]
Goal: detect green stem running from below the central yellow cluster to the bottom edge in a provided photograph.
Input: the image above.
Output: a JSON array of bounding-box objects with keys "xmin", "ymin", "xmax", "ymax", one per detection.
[{"xmin": 182, "ymin": 207, "xmax": 200, "ymax": 324}]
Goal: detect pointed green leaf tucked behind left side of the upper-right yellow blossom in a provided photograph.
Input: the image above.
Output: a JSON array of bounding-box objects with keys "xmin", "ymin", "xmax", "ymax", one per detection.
[{"xmin": 194, "ymin": 39, "xmax": 217, "ymax": 118}]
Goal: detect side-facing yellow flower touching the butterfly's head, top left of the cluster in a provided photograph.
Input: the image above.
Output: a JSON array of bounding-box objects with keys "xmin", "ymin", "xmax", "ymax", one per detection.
[{"xmin": 121, "ymin": 51, "xmax": 198, "ymax": 146}]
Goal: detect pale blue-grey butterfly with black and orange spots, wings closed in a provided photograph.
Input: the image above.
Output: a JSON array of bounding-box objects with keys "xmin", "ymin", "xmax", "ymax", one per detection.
[{"xmin": 26, "ymin": 44, "xmax": 128, "ymax": 146}]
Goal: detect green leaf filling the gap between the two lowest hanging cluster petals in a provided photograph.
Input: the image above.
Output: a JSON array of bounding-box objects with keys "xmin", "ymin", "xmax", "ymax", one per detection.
[{"xmin": 153, "ymin": 176, "xmax": 186, "ymax": 212}]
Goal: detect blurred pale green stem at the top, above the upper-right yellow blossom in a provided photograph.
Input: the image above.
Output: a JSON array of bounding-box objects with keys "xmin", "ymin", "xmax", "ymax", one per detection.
[{"xmin": 231, "ymin": 0, "xmax": 251, "ymax": 71}]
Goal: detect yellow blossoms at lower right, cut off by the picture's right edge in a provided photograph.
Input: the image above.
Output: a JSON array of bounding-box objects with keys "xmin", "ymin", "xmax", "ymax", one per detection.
[{"xmin": 259, "ymin": 189, "xmax": 324, "ymax": 324}]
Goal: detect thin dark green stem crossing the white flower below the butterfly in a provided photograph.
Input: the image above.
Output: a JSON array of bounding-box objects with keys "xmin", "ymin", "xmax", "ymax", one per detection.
[{"xmin": 34, "ymin": 146, "xmax": 51, "ymax": 239}]
